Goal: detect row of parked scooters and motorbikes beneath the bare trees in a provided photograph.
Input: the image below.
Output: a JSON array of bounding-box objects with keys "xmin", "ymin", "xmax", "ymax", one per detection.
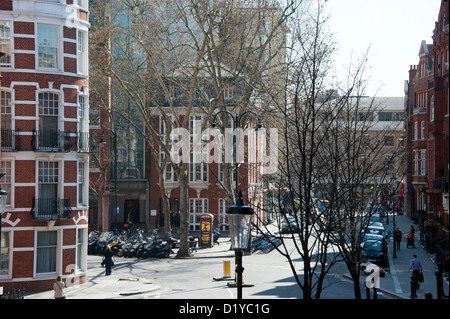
[{"xmin": 88, "ymin": 229, "xmax": 179, "ymax": 259}]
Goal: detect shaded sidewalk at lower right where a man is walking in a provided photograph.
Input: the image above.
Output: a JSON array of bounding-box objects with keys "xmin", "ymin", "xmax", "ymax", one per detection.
[{"xmin": 370, "ymin": 215, "xmax": 449, "ymax": 299}]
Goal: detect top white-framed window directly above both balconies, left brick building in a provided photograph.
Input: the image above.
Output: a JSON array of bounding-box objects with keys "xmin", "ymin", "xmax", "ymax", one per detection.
[{"xmin": 37, "ymin": 24, "xmax": 59, "ymax": 69}]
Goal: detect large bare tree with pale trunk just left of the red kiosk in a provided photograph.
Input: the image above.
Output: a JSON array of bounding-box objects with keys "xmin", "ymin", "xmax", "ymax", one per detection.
[{"xmin": 90, "ymin": 0, "xmax": 295, "ymax": 256}]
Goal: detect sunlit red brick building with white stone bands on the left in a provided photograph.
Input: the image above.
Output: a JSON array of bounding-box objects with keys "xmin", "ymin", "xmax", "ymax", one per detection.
[{"xmin": 0, "ymin": 0, "xmax": 89, "ymax": 292}]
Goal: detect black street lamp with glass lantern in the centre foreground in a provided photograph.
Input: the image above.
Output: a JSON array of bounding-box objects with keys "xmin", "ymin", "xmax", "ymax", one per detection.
[{"xmin": 227, "ymin": 191, "xmax": 253, "ymax": 299}]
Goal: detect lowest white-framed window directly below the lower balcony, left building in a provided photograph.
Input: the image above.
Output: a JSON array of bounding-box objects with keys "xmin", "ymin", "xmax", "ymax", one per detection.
[{"xmin": 36, "ymin": 231, "xmax": 58, "ymax": 275}]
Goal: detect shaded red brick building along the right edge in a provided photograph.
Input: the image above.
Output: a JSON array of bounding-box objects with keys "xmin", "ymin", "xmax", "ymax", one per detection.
[{"xmin": 405, "ymin": 0, "xmax": 449, "ymax": 269}]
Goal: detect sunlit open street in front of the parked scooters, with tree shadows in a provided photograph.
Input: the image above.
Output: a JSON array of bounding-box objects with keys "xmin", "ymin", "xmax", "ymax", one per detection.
[{"xmin": 26, "ymin": 238, "xmax": 383, "ymax": 300}]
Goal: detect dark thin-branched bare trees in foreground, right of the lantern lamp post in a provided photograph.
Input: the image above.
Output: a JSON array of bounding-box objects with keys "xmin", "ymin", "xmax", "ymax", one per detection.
[{"xmin": 250, "ymin": 1, "xmax": 404, "ymax": 299}]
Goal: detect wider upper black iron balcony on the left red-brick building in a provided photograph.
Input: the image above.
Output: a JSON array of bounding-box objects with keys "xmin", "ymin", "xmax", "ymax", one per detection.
[{"xmin": 31, "ymin": 130, "xmax": 89, "ymax": 152}]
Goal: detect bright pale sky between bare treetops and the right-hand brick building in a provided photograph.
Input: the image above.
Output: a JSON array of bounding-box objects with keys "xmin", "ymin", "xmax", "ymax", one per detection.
[{"xmin": 325, "ymin": 0, "xmax": 441, "ymax": 97}]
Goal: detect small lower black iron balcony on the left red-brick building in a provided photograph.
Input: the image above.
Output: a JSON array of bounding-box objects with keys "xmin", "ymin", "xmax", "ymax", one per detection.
[{"xmin": 31, "ymin": 198, "xmax": 72, "ymax": 220}]
